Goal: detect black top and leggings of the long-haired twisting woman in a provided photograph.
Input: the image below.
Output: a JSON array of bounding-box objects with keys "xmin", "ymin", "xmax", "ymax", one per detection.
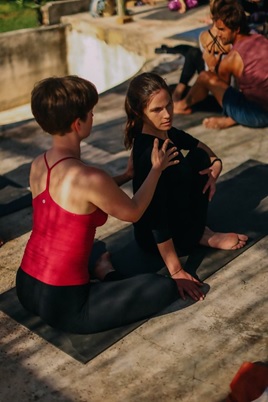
[{"xmin": 133, "ymin": 128, "xmax": 210, "ymax": 252}]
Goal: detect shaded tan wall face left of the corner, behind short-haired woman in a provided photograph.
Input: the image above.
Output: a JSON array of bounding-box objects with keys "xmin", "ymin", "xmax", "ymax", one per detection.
[{"xmin": 0, "ymin": 25, "xmax": 68, "ymax": 111}]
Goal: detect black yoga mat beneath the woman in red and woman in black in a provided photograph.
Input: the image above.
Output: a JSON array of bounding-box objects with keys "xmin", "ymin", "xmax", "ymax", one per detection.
[{"xmin": 0, "ymin": 160, "xmax": 268, "ymax": 363}]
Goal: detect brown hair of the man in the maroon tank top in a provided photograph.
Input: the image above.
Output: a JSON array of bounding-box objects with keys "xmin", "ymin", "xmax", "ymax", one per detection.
[{"xmin": 211, "ymin": 0, "xmax": 250, "ymax": 35}]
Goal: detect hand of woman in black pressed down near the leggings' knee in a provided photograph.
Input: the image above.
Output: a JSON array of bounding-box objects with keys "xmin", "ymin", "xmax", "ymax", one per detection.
[{"xmin": 172, "ymin": 269, "xmax": 205, "ymax": 301}]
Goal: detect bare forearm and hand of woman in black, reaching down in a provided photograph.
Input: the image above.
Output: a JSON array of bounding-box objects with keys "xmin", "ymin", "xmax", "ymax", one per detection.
[{"xmin": 157, "ymin": 239, "xmax": 204, "ymax": 301}]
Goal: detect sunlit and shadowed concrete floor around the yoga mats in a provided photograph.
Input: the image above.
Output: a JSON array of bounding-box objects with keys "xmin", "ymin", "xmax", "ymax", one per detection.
[{"xmin": 0, "ymin": 6, "xmax": 268, "ymax": 402}]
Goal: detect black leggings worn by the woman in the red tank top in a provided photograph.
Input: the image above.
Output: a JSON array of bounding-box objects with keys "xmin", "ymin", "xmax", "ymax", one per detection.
[{"xmin": 16, "ymin": 268, "xmax": 178, "ymax": 334}]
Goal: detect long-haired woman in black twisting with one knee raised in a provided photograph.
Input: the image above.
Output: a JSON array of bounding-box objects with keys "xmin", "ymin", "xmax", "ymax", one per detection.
[{"xmin": 125, "ymin": 73, "xmax": 247, "ymax": 300}]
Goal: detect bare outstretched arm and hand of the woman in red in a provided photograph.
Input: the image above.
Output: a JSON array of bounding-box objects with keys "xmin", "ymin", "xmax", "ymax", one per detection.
[{"xmin": 88, "ymin": 140, "xmax": 178, "ymax": 222}]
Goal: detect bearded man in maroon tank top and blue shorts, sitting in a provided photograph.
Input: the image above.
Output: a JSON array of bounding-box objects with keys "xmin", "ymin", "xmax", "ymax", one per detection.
[{"xmin": 174, "ymin": 0, "xmax": 268, "ymax": 129}]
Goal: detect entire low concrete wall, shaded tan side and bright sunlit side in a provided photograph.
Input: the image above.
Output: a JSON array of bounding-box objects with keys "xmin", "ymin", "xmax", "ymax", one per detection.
[{"xmin": 0, "ymin": 12, "xmax": 146, "ymax": 113}]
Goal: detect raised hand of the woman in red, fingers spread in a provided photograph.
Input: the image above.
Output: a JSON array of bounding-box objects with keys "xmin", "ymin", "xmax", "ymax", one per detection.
[{"xmin": 151, "ymin": 138, "xmax": 179, "ymax": 171}]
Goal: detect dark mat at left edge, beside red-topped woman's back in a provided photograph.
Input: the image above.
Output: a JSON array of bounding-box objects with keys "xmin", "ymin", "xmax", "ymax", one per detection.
[{"xmin": 0, "ymin": 176, "xmax": 32, "ymax": 216}]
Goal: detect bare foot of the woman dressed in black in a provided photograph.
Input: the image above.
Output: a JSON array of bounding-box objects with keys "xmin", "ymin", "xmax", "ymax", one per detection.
[{"xmin": 199, "ymin": 226, "xmax": 248, "ymax": 250}]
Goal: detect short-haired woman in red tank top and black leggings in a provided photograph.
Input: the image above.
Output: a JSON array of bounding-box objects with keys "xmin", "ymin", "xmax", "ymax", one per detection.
[{"xmin": 16, "ymin": 76, "xmax": 182, "ymax": 333}]
